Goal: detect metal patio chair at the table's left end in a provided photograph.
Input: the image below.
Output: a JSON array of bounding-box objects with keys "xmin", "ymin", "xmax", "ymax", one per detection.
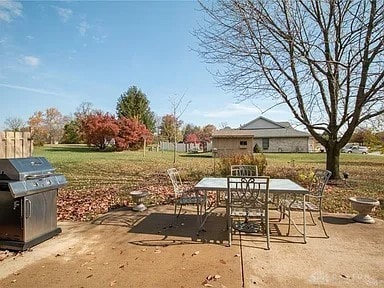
[{"xmin": 167, "ymin": 168, "xmax": 206, "ymax": 225}]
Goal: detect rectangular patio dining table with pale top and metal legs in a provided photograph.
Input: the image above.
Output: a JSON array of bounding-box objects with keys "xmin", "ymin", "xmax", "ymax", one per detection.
[{"xmin": 195, "ymin": 177, "xmax": 309, "ymax": 243}]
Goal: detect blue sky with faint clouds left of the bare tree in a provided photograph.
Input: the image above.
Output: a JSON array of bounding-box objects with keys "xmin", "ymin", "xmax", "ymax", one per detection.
[{"xmin": 0, "ymin": 0, "xmax": 293, "ymax": 130}]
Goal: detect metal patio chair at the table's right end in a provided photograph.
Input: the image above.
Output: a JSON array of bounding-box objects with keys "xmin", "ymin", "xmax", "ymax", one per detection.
[{"xmin": 280, "ymin": 169, "xmax": 332, "ymax": 238}]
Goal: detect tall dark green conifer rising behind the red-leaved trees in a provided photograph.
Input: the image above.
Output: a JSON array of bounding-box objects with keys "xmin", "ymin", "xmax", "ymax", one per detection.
[{"xmin": 116, "ymin": 86, "xmax": 155, "ymax": 132}]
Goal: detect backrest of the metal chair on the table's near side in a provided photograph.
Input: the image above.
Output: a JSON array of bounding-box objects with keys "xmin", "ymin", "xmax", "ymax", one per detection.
[{"xmin": 227, "ymin": 176, "xmax": 269, "ymax": 209}]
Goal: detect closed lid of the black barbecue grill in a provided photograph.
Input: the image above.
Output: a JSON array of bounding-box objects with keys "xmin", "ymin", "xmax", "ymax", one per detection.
[{"xmin": 0, "ymin": 157, "xmax": 55, "ymax": 181}]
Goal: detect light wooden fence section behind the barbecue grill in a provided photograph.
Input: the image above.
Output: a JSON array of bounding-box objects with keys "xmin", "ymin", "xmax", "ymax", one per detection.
[{"xmin": 0, "ymin": 131, "xmax": 33, "ymax": 158}]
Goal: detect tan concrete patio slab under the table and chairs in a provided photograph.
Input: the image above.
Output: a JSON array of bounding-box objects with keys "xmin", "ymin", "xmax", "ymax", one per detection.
[{"xmin": 0, "ymin": 206, "xmax": 384, "ymax": 288}]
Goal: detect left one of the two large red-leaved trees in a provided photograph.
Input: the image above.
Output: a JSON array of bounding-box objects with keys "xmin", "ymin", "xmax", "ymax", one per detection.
[{"xmin": 82, "ymin": 112, "xmax": 120, "ymax": 150}]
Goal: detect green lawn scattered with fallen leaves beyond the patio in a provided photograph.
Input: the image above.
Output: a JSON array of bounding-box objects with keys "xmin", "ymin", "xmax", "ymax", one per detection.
[{"xmin": 34, "ymin": 145, "xmax": 384, "ymax": 220}]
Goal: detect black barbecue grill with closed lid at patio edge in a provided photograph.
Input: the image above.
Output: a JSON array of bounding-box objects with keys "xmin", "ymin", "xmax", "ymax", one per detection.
[{"xmin": 0, "ymin": 157, "xmax": 67, "ymax": 250}]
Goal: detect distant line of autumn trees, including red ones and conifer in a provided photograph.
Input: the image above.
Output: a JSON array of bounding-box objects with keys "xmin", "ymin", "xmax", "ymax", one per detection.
[{"xmin": 4, "ymin": 86, "xmax": 216, "ymax": 151}]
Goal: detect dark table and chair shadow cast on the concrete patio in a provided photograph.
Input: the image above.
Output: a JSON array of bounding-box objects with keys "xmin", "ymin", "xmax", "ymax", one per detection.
[{"xmin": 92, "ymin": 207, "xmax": 227, "ymax": 246}]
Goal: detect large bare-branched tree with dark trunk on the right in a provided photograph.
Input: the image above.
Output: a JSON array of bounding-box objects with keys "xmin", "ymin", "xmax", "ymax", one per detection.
[{"xmin": 195, "ymin": 0, "xmax": 384, "ymax": 178}]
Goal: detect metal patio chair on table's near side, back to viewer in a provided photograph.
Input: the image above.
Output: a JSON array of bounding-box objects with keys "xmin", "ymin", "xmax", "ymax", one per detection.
[{"xmin": 227, "ymin": 176, "xmax": 270, "ymax": 250}]
